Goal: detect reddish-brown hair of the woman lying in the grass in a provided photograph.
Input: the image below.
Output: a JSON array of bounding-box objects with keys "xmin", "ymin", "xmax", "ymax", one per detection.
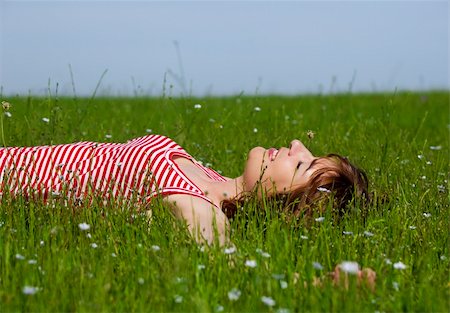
[{"xmin": 222, "ymin": 154, "xmax": 369, "ymax": 218}]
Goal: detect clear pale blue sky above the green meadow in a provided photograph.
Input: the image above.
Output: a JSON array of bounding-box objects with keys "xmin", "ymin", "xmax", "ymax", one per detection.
[{"xmin": 0, "ymin": 0, "xmax": 450, "ymax": 96}]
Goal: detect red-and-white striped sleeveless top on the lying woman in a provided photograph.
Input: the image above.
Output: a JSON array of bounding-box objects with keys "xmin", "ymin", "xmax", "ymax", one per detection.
[{"xmin": 0, "ymin": 135, "xmax": 225, "ymax": 203}]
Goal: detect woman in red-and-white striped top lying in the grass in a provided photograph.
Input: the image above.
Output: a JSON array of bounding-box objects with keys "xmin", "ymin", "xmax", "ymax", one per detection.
[{"xmin": 0, "ymin": 135, "xmax": 368, "ymax": 243}]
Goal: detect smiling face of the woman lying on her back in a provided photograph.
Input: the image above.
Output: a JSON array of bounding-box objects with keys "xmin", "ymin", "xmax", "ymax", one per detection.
[{"xmin": 243, "ymin": 140, "xmax": 323, "ymax": 195}]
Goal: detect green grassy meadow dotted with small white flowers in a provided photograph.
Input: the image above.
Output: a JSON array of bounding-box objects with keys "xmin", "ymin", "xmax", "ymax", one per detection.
[{"xmin": 0, "ymin": 92, "xmax": 450, "ymax": 313}]
